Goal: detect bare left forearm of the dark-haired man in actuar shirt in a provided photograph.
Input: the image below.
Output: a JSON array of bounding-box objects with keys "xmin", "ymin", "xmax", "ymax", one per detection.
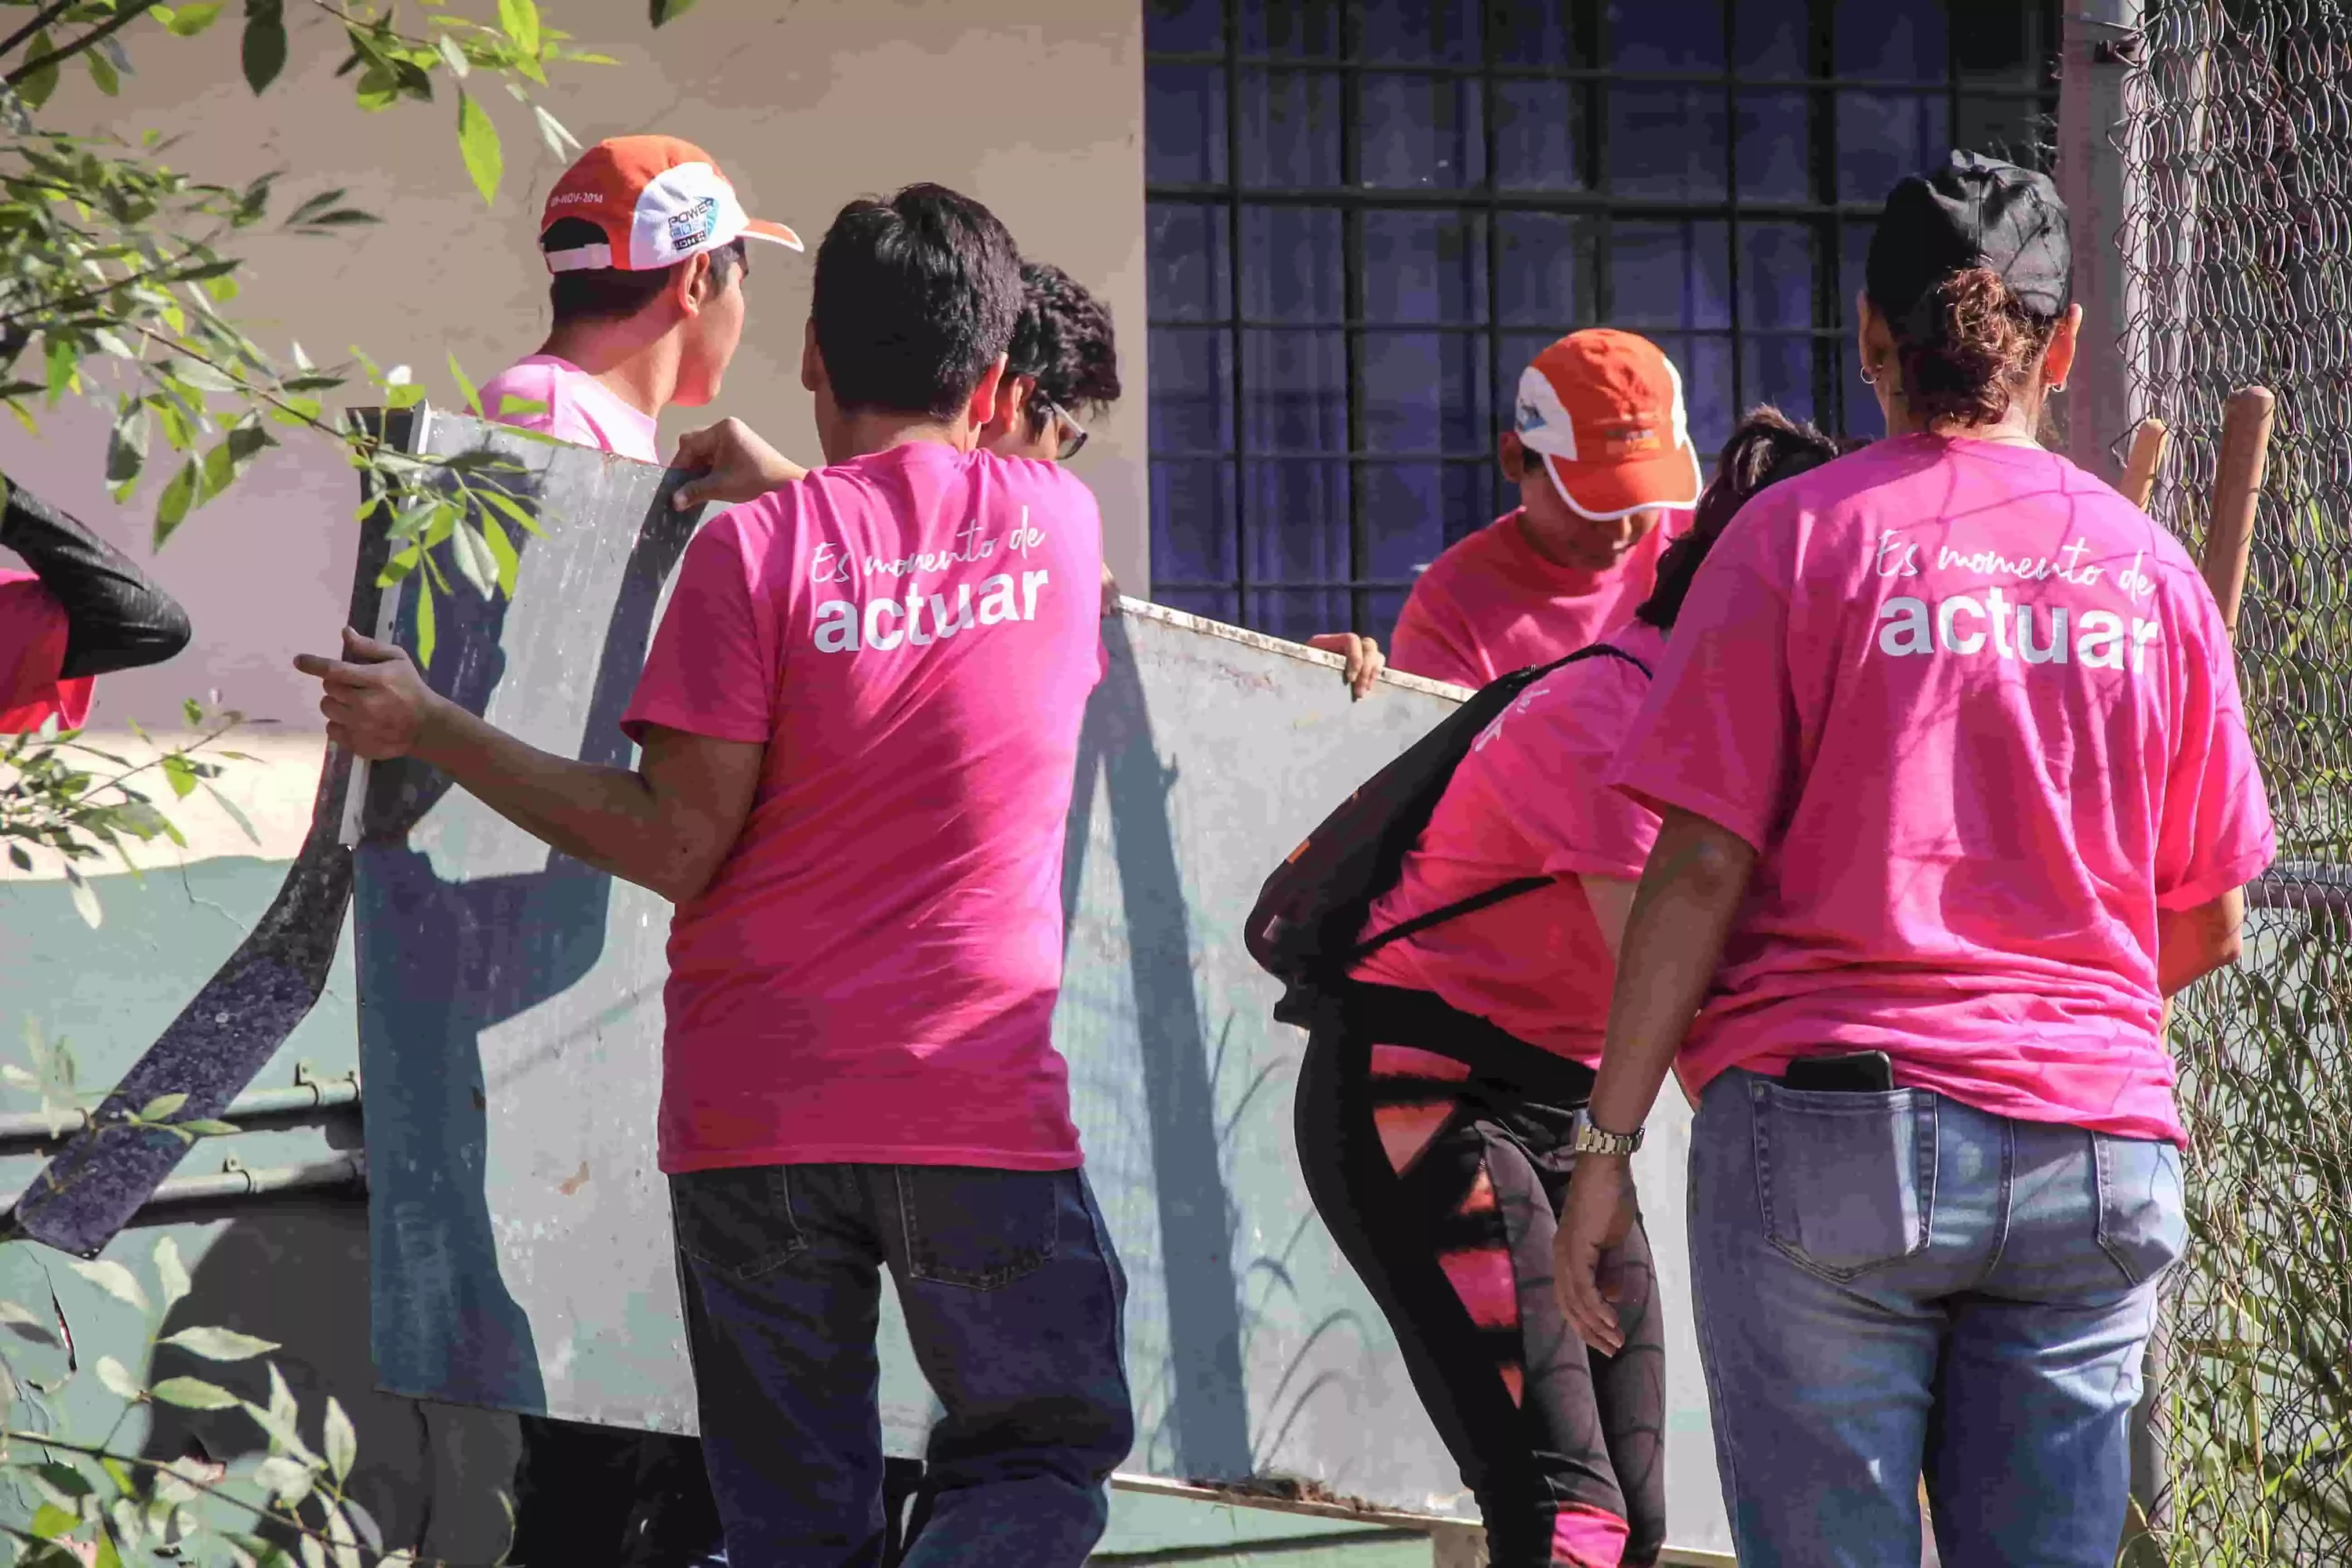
[{"xmin": 416, "ymin": 703, "xmax": 685, "ymax": 898}]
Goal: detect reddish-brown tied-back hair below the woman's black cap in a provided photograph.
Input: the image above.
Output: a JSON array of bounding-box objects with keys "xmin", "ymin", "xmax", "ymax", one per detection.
[{"xmin": 1872, "ymin": 265, "xmax": 2058, "ymax": 430}]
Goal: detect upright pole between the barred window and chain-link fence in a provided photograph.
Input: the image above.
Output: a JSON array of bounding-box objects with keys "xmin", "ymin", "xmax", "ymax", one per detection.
[{"xmin": 2058, "ymin": 0, "xmax": 2150, "ymax": 482}]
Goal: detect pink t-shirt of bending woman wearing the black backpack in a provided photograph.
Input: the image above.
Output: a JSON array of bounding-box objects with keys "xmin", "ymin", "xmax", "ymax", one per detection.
[{"xmin": 1355, "ymin": 621, "xmax": 1665, "ymax": 1067}]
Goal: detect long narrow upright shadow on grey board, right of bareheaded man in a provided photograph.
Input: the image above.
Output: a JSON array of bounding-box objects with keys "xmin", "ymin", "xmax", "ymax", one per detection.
[{"xmin": 1061, "ymin": 616, "xmax": 1251, "ymax": 1481}]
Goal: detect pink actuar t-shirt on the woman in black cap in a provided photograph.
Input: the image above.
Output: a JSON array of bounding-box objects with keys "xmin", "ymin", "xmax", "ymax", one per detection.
[{"xmin": 1611, "ymin": 435, "xmax": 2272, "ymax": 1140}]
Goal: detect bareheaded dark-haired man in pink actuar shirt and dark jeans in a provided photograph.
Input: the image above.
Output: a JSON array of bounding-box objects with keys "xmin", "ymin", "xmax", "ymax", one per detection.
[{"xmin": 299, "ymin": 186, "xmax": 1134, "ymax": 1568}]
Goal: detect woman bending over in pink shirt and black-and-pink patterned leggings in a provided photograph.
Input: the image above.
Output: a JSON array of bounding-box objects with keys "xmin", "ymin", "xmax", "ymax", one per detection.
[{"xmin": 1298, "ymin": 409, "xmax": 1837, "ymax": 1568}]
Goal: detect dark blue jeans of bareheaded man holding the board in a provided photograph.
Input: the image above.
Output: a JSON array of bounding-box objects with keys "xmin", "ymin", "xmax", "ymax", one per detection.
[{"xmin": 670, "ymin": 1166, "xmax": 1134, "ymax": 1568}]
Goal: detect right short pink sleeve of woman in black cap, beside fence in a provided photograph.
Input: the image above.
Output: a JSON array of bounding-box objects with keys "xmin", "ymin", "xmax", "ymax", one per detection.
[{"xmin": 2157, "ymin": 590, "xmax": 2277, "ymax": 910}]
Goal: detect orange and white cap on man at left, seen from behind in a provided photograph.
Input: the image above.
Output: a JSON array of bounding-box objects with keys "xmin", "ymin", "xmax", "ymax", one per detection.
[{"xmin": 539, "ymin": 137, "xmax": 802, "ymax": 273}]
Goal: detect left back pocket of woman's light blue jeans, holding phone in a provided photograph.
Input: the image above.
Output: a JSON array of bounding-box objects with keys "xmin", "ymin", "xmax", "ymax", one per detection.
[{"xmin": 1752, "ymin": 1079, "xmax": 1936, "ymax": 1279}]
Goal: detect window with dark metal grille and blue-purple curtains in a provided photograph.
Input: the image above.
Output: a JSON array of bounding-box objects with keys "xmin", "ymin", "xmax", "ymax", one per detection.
[{"xmin": 1146, "ymin": 0, "xmax": 2058, "ymax": 642}]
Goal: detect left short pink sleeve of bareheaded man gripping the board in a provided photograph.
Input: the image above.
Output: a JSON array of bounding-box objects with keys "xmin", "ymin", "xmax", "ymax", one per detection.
[{"xmin": 621, "ymin": 508, "xmax": 783, "ymax": 743}]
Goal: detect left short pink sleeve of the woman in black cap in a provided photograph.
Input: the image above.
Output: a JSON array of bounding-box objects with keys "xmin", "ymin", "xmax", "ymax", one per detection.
[{"xmin": 1609, "ymin": 496, "xmax": 1799, "ymax": 851}]
